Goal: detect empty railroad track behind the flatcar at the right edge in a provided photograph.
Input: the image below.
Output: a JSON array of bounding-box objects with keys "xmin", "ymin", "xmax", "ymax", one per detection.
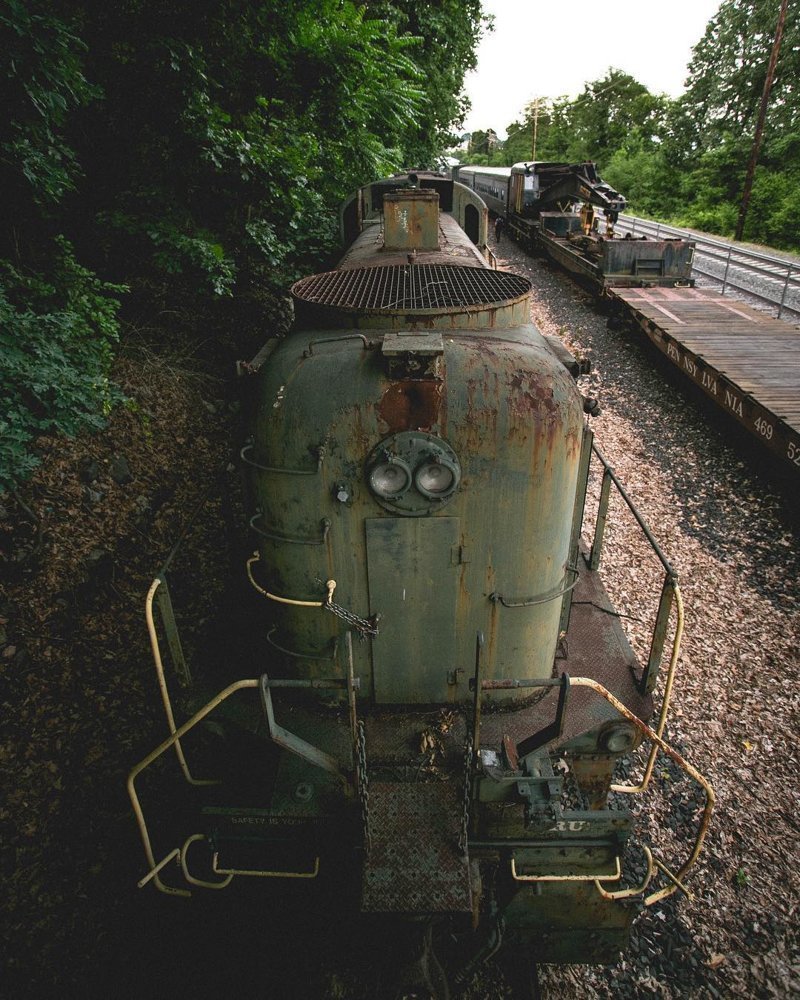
[{"xmin": 616, "ymin": 215, "xmax": 800, "ymax": 322}]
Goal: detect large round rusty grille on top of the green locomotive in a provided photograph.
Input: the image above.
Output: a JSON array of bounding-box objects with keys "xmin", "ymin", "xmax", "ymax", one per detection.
[{"xmin": 292, "ymin": 264, "xmax": 531, "ymax": 328}]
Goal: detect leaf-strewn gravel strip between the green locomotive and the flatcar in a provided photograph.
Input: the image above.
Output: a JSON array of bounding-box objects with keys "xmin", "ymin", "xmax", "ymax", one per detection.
[{"xmin": 484, "ymin": 230, "xmax": 800, "ymax": 998}]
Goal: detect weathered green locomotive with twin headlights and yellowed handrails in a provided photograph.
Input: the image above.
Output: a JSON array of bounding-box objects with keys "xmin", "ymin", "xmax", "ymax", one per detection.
[{"xmin": 128, "ymin": 175, "xmax": 713, "ymax": 995}]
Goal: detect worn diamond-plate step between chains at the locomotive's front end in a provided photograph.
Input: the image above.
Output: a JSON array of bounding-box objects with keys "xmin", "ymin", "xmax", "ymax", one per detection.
[{"xmin": 361, "ymin": 781, "xmax": 472, "ymax": 914}]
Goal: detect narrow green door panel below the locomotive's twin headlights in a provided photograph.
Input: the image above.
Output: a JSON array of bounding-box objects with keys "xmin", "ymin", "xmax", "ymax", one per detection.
[{"xmin": 366, "ymin": 517, "xmax": 459, "ymax": 704}]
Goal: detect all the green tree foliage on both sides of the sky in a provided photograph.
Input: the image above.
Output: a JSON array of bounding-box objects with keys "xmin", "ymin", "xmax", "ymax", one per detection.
[{"xmin": 0, "ymin": 0, "xmax": 800, "ymax": 492}]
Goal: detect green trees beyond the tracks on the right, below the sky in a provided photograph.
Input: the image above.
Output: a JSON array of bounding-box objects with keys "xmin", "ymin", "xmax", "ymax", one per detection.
[{"xmin": 460, "ymin": 0, "xmax": 800, "ymax": 250}]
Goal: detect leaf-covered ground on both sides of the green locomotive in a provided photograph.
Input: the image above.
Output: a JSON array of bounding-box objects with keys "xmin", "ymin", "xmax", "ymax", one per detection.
[{"xmin": 0, "ymin": 240, "xmax": 800, "ymax": 1000}]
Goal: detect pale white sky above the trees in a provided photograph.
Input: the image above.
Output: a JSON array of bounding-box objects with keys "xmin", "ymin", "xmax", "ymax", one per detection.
[{"xmin": 464, "ymin": 0, "xmax": 721, "ymax": 138}]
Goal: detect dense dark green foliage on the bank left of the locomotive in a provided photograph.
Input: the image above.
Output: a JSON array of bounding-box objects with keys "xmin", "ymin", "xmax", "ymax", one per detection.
[{"xmin": 0, "ymin": 0, "xmax": 484, "ymax": 492}]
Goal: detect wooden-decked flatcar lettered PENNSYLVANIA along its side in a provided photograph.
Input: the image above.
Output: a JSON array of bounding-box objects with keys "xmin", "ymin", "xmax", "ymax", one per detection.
[{"xmin": 607, "ymin": 288, "xmax": 800, "ymax": 472}]
